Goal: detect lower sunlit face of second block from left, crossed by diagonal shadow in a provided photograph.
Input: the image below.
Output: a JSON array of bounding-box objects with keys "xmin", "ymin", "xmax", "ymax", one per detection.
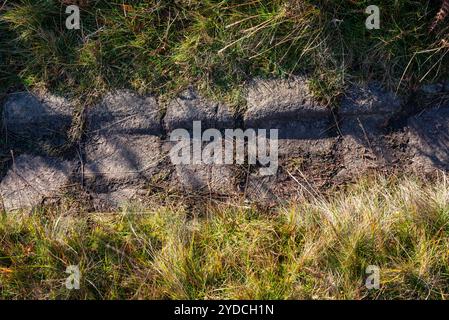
[{"xmin": 82, "ymin": 135, "xmax": 163, "ymax": 189}]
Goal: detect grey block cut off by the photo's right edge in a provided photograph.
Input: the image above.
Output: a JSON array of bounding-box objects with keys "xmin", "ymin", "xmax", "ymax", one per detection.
[{"xmin": 408, "ymin": 106, "xmax": 449, "ymax": 173}]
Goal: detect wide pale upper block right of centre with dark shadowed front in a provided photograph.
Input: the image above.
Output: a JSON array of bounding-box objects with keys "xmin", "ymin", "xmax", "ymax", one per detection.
[{"xmin": 244, "ymin": 78, "xmax": 332, "ymax": 139}]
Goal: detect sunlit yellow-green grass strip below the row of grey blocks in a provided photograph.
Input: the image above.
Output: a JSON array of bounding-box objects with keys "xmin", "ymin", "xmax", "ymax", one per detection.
[{"xmin": 0, "ymin": 178, "xmax": 449, "ymax": 299}]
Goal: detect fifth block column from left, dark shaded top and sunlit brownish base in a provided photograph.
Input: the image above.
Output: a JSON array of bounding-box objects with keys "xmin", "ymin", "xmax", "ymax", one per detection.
[{"xmin": 338, "ymin": 83, "xmax": 403, "ymax": 180}]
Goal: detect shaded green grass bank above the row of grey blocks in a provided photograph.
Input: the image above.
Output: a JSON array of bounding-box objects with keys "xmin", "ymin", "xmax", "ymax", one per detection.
[{"xmin": 0, "ymin": 0, "xmax": 449, "ymax": 105}]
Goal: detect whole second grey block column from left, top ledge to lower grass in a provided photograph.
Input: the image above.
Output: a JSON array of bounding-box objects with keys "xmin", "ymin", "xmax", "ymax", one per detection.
[{"xmin": 78, "ymin": 90, "xmax": 164, "ymax": 210}]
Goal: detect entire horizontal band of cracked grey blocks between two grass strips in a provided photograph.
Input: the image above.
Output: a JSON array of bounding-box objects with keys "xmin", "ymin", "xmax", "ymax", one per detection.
[{"xmin": 0, "ymin": 81, "xmax": 449, "ymax": 211}]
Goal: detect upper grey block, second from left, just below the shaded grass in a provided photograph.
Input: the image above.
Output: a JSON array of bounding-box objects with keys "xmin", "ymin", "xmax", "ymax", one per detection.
[{"xmin": 87, "ymin": 90, "xmax": 162, "ymax": 135}]
